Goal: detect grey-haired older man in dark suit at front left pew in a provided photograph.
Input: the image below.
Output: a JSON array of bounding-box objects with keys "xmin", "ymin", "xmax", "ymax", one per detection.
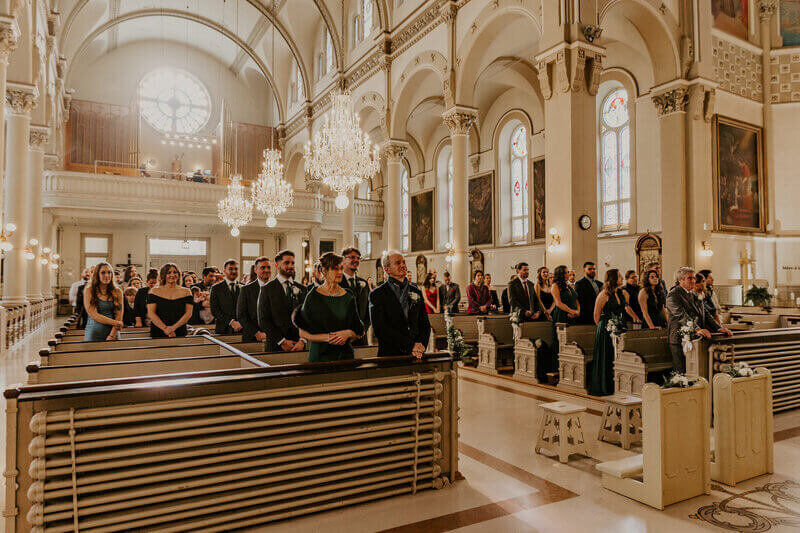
[{"xmin": 369, "ymin": 250, "xmax": 431, "ymax": 359}]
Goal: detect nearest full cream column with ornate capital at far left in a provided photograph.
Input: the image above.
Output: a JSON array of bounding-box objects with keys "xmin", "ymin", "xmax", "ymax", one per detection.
[{"xmin": 3, "ymin": 83, "xmax": 39, "ymax": 304}]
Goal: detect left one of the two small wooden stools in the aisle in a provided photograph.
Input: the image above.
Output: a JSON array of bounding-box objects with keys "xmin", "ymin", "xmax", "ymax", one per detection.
[{"xmin": 534, "ymin": 402, "xmax": 589, "ymax": 463}]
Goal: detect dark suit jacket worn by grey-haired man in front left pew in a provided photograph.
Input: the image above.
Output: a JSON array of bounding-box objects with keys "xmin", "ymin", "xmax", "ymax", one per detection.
[{"xmin": 369, "ymin": 281, "xmax": 431, "ymax": 357}]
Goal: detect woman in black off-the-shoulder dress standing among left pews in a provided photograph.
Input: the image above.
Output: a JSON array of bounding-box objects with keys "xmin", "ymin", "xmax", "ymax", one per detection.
[{"xmin": 147, "ymin": 263, "xmax": 192, "ymax": 338}]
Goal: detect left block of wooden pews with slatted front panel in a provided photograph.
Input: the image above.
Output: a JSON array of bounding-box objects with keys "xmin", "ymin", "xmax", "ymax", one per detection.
[{"xmin": 3, "ymin": 319, "xmax": 458, "ymax": 533}]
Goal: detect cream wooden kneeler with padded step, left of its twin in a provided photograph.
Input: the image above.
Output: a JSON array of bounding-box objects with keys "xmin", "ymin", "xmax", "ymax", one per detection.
[{"xmin": 597, "ymin": 378, "xmax": 711, "ymax": 509}]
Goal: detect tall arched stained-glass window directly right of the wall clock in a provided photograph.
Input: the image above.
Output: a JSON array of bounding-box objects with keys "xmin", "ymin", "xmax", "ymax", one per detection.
[{"xmin": 599, "ymin": 87, "xmax": 631, "ymax": 231}]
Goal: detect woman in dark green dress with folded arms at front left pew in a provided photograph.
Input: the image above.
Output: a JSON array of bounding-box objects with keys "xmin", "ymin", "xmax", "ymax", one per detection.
[{"xmin": 294, "ymin": 252, "xmax": 364, "ymax": 363}]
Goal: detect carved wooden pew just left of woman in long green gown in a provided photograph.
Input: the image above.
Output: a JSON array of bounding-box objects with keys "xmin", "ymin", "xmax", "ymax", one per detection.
[{"xmin": 556, "ymin": 324, "xmax": 595, "ymax": 394}]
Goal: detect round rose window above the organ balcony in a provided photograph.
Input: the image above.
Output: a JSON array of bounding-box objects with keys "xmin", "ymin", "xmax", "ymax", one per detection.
[{"xmin": 139, "ymin": 68, "xmax": 211, "ymax": 134}]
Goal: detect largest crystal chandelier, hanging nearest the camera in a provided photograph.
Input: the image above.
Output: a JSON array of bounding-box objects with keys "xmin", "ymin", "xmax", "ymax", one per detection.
[{"xmin": 305, "ymin": 90, "xmax": 379, "ymax": 209}]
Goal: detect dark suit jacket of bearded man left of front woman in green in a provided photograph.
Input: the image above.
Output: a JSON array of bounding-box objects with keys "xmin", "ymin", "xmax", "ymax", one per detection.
[{"xmin": 258, "ymin": 278, "xmax": 306, "ymax": 352}]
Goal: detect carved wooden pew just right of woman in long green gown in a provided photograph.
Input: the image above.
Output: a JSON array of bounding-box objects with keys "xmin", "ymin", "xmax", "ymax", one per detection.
[{"xmin": 614, "ymin": 329, "xmax": 672, "ymax": 396}]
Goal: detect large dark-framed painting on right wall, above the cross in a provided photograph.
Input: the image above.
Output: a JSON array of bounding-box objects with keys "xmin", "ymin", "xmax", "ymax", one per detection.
[{"xmin": 712, "ymin": 115, "xmax": 766, "ymax": 232}]
